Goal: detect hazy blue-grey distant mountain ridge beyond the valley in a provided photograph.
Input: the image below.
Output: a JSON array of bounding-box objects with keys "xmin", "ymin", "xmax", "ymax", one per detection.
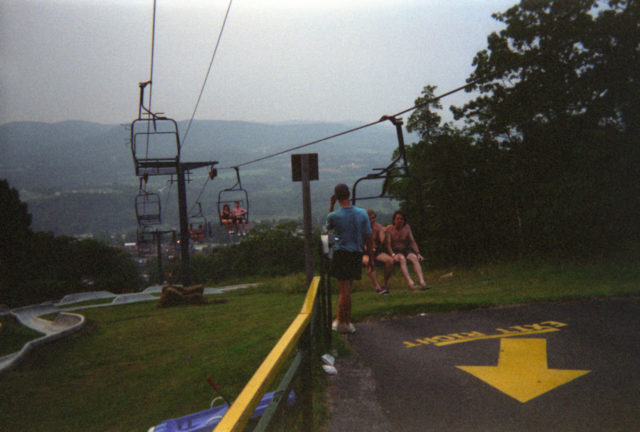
[{"xmin": 0, "ymin": 121, "xmax": 411, "ymax": 235}]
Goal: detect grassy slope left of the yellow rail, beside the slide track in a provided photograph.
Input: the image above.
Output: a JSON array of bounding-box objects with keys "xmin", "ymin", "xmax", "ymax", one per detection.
[{"xmin": 0, "ymin": 286, "xmax": 303, "ymax": 431}]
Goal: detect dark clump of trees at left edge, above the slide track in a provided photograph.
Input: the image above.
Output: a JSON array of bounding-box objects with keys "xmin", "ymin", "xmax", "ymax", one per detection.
[{"xmin": 0, "ymin": 180, "xmax": 139, "ymax": 307}]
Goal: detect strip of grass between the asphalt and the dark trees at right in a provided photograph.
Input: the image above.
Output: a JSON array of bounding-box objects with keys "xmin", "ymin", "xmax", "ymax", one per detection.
[{"xmin": 353, "ymin": 261, "xmax": 640, "ymax": 321}]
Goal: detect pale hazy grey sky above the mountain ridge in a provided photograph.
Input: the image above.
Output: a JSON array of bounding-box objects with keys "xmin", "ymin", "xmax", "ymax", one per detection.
[{"xmin": 0, "ymin": 0, "xmax": 516, "ymax": 124}]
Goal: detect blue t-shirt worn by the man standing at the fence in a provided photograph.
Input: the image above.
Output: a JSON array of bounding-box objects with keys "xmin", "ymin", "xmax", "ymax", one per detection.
[{"xmin": 327, "ymin": 206, "xmax": 371, "ymax": 252}]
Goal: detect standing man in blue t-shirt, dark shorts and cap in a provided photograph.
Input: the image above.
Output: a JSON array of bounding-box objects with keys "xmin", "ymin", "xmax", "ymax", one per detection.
[{"xmin": 327, "ymin": 183, "xmax": 374, "ymax": 333}]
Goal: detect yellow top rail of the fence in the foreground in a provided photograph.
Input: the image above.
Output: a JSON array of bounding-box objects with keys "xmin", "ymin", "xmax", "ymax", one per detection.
[{"xmin": 213, "ymin": 276, "xmax": 320, "ymax": 432}]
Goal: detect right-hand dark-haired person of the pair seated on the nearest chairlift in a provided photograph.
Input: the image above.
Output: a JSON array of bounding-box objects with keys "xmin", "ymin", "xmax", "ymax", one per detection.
[{"xmin": 386, "ymin": 210, "xmax": 429, "ymax": 290}]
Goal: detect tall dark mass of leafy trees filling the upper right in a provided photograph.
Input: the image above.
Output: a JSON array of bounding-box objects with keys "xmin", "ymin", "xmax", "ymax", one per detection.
[{"xmin": 394, "ymin": 0, "xmax": 640, "ymax": 260}]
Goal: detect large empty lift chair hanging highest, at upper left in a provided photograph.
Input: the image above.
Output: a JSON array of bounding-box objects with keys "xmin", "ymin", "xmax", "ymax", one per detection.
[{"xmin": 131, "ymin": 81, "xmax": 180, "ymax": 177}]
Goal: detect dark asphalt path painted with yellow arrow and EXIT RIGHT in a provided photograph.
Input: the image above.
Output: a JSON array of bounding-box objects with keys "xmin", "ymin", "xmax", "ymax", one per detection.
[{"xmin": 328, "ymin": 297, "xmax": 640, "ymax": 432}]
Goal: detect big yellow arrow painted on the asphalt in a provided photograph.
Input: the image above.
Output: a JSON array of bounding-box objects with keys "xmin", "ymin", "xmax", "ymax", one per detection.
[{"xmin": 457, "ymin": 338, "xmax": 590, "ymax": 403}]
